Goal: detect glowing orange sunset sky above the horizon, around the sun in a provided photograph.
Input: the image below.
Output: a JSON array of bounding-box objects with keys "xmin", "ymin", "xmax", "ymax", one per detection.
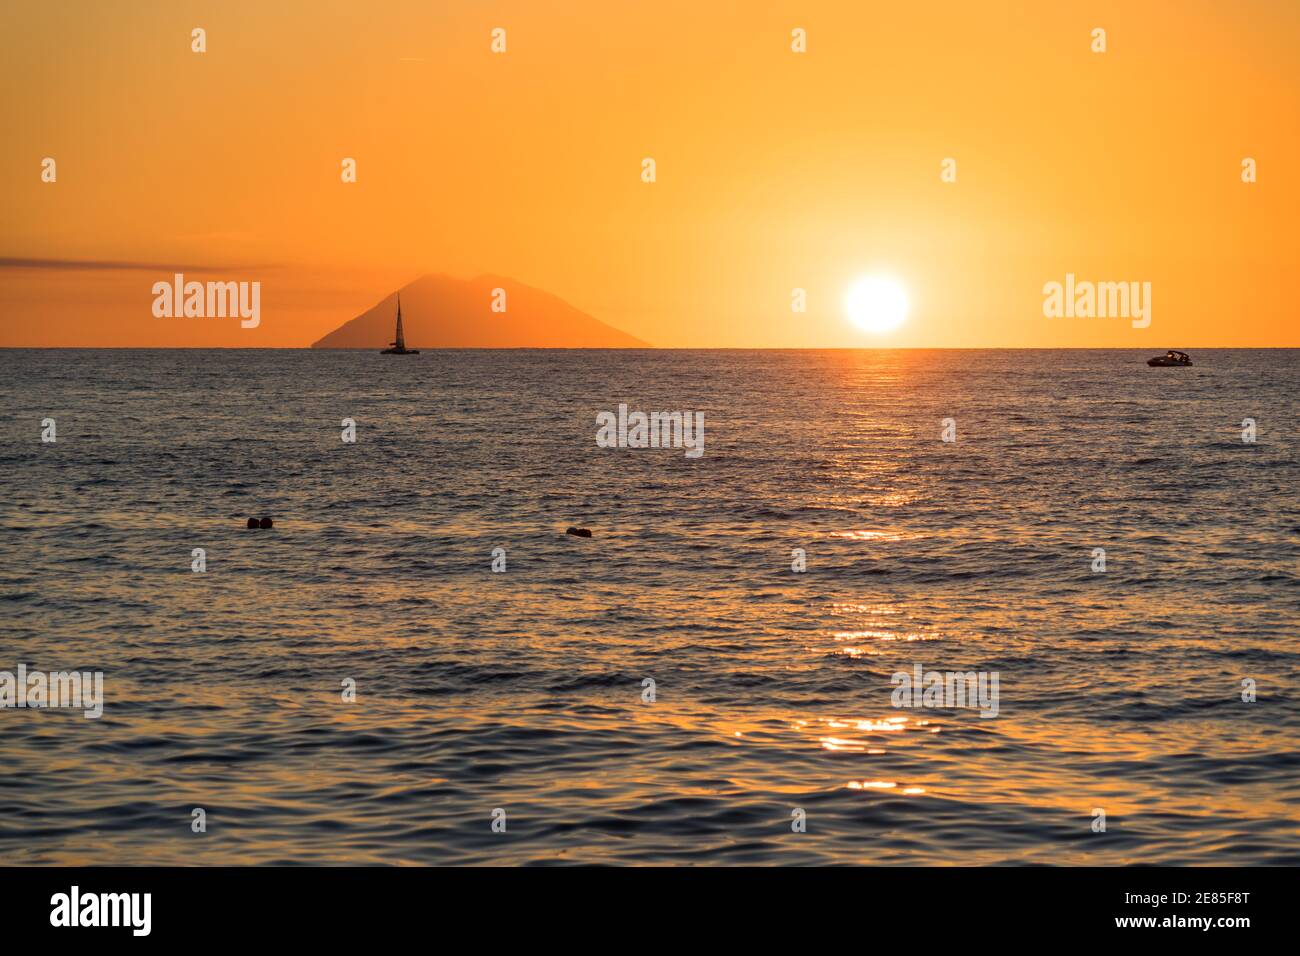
[{"xmin": 0, "ymin": 0, "xmax": 1300, "ymax": 351}]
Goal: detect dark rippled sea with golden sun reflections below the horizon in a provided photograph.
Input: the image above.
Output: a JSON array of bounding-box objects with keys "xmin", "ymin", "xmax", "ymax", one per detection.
[{"xmin": 0, "ymin": 350, "xmax": 1300, "ymax": 865}]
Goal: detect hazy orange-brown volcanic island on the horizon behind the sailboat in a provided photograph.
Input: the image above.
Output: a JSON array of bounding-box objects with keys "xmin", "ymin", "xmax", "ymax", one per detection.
[{"xmin": 312, "ymin": 274, "xmax": 650, "ymax": 349}]
